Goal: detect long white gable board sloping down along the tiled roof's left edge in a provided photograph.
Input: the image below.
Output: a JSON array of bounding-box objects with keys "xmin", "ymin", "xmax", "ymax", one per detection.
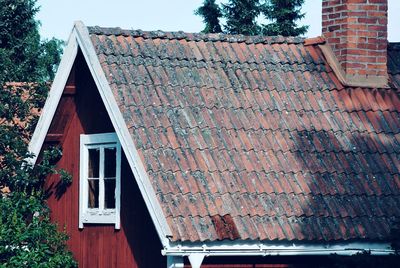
[{"xmin": 74, "ymin": 21, "xmax": 172, "ymax": 248}]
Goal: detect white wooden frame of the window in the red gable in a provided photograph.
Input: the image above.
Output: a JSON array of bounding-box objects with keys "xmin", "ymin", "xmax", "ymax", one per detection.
[{"xmin": 79, "ymin": 133, "xmax": 121, "ymax": 229}]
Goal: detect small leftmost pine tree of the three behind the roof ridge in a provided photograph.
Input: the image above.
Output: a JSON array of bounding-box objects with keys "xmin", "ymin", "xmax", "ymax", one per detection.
[{"xmin": 194, "ymin": 0, "xmax": 222, "ymax": 33}]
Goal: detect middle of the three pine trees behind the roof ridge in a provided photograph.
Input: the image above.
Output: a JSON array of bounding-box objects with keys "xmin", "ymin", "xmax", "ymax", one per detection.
[{"xmin": 222, "ymin": 0, "xmax": 260, "ymax": 35}]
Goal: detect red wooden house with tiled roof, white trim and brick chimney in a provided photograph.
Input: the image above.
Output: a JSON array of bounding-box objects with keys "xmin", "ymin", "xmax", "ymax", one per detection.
[{"xmin": 30, "ymin": 0, "xmax": 400, "ymax": 268}]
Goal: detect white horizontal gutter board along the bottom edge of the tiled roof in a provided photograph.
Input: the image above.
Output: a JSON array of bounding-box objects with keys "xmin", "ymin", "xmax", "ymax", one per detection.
[{"xmin": 162, "ymin": 241, "xmax": 394, "ymax": 257}]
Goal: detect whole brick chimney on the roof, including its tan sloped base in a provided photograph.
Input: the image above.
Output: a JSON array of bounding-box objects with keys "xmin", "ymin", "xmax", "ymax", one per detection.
[{"xmin": 322, "ymin": 0, "xmax": 388, "ymax": 87}]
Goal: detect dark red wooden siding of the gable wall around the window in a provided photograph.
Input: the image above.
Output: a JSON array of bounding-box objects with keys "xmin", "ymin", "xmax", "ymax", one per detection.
[{"xmin": 45, "ymin": 50, "xmax": 166, "ymax": 268}]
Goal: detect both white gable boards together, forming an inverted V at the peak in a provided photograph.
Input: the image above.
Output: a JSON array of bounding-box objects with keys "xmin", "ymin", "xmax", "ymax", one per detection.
[{"xmin": 29, "ymin": 21, "xmax": 172, "ymax": 248}]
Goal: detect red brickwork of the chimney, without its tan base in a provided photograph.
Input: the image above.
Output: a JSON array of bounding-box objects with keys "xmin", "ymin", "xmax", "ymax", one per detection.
[{"xmin": 322, "ymin": 0, "xmax": 387, "ymax": 75}]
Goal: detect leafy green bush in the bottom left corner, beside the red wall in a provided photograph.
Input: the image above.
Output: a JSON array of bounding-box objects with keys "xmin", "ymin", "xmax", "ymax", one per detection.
[{"xmin": 0, "ymin": 191, "xmax": 76, "ymax": 267}]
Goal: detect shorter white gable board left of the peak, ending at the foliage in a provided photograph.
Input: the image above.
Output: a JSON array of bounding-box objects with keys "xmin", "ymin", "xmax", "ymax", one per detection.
[{"xmin": 28, "ymin": 29, "xmax": 78, "ymax": 165}]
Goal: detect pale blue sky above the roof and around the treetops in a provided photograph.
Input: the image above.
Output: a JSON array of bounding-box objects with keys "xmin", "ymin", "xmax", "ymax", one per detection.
[{"xmin": 37, "ymin": 0, "xmax": 400, "ymax": 42}]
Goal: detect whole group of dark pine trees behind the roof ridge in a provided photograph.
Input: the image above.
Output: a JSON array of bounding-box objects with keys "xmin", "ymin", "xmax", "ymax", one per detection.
[{"xmin": 195, "ymin": 0, "xmax": 308, "ymax": 36}]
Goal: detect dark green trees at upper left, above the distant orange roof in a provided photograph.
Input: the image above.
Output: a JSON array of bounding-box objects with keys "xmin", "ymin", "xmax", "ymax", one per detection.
[{"xmin": 0, "ymin": 0, "xmax": 63, "ymax": 82}]
